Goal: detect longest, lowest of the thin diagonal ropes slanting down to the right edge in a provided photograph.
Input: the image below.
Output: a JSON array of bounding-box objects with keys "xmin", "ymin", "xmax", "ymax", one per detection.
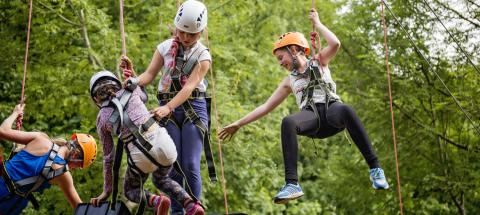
[{"xmin": 381, "ymin": 0, "xmax": 480, "ymax": 135}]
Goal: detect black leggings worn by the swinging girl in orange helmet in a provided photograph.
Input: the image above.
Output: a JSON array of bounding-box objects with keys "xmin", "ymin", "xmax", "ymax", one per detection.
[{"xmin": 282, "ymin": 102, "xmax": 380, "ymax": 183}]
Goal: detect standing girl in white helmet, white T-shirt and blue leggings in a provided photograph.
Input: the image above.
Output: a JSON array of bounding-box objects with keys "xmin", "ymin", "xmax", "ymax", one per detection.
[{"xmin": 122, "ymin": 0, "xmax": 211, "ymax": 214}]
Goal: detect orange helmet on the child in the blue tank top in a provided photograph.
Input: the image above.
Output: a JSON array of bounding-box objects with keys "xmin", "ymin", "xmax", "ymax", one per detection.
[{"xmin": 72, "ymin": 133, "xmax": 97, "ymax": 168}]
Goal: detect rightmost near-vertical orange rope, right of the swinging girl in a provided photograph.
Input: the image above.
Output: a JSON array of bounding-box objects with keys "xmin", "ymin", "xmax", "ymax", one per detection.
[{"xmin": 381, "ymin": 0, "xmax": 403, "ymax": 215}]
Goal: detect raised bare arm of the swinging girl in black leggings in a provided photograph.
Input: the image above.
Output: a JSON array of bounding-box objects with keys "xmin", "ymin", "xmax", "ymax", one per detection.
[{"xmin": 309, "ymin": 8, "xmax": 340, "ymax": 66}]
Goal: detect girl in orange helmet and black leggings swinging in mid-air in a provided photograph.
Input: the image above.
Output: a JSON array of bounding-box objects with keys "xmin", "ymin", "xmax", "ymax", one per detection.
[{"xmin": 219, "ymin": 8, "xmax": 389, "ymax": 204}]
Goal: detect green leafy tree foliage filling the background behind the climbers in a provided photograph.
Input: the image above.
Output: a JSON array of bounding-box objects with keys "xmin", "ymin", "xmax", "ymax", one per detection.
[{"xmin": 0, "ymin": 0, "xmax": 480, "ymax": 214}]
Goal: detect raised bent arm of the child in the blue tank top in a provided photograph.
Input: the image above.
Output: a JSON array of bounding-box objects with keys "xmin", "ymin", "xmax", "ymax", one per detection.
[{"xmin": 0, "ymin": 104, "xmax": 41, "ymax": 145}]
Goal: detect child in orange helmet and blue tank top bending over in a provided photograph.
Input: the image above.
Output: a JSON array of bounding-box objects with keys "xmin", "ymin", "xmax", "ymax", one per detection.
[{"xmin": 0, "ymin": 104, "xmax": 97, "ymax": 214}]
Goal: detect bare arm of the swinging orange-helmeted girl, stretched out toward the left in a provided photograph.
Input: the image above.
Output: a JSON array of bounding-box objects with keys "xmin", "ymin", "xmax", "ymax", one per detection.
[{"xmin": 218, "ymin": 77, "xmax": 292, "ymax": 140}]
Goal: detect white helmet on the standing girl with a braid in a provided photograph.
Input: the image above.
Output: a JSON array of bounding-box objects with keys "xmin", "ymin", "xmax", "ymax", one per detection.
[{"xmin": 173, "ymin": 0, "xmax": 208, "ymax": 34}]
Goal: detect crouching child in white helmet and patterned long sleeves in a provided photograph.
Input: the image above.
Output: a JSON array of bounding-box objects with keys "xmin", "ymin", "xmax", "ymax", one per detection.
[{"xmin": 90, "ymin": 71, "xmax": 203, "ymax": 215}]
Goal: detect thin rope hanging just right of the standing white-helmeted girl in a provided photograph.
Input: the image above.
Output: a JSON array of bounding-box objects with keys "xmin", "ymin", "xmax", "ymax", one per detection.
[{"xmin": 205, "ymin": 0, "xmax": 228, "ymax": 214}]
